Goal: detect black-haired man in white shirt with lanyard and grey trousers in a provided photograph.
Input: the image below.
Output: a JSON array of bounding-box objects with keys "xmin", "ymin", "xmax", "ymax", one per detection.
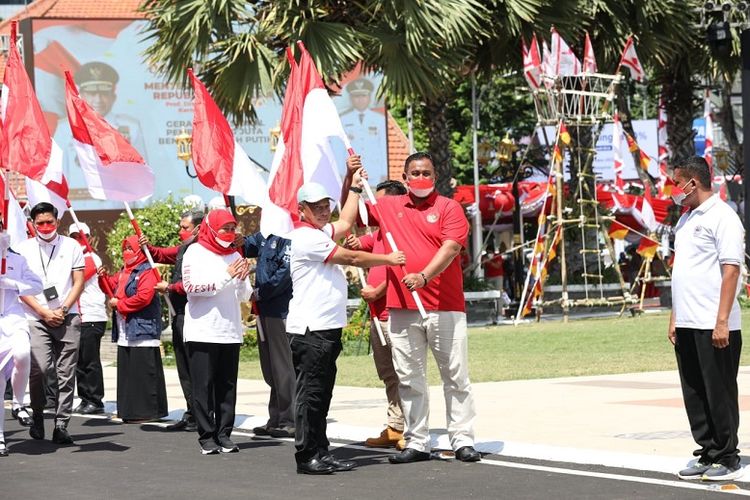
[{"xmin": 17, "ymin": 202, "xmax": 85, "ymax": 444}]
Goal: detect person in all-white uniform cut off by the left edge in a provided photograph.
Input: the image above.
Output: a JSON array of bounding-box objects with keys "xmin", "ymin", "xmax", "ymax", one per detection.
[{"xmin": 0, "ymin": 229, "xmax": 44, "ymax": 457}]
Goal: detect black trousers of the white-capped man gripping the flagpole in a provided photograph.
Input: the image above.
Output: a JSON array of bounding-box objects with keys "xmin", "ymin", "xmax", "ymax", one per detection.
[{"xmin": 287, "ymin": 328, "xmax": 341, "ymax": 464}]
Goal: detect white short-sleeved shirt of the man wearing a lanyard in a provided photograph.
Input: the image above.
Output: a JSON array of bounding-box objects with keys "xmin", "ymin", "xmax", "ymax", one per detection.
[{"xmin": 16, "ymin": 235, "xmax": 85, "ymax": 321}]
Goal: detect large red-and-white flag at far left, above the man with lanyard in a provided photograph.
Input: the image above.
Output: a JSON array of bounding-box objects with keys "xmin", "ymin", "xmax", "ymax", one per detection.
[{"xmin": 2, "ymin": 21, "xmax": 62, "ymax": 182}]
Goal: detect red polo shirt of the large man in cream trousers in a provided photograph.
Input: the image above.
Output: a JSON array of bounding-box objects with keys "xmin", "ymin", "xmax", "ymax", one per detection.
[{"xmin": 368, "ymin": 192, "xmax": 469, "ymax": 312}]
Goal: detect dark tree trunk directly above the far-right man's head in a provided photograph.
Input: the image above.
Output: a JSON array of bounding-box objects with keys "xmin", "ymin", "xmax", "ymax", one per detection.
[{"xmin": 662, "ymin": 60, "xmax": 695, "ymax": 165}]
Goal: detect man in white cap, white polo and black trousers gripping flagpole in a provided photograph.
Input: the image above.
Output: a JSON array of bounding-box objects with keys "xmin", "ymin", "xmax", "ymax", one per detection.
[{"xmin": 285, "ymin": 173, "xmax": 406, "ymax": 474}]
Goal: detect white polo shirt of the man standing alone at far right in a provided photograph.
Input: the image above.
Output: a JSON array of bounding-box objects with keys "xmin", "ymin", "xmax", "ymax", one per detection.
[{"xmin": 672, "ymin": 195, "xmax": 745, "ymax": 330}]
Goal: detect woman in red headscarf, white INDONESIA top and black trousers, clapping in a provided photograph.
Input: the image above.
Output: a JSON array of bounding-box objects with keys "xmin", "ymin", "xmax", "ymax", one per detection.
[{"xmin": 182, "ymin": 209, "xmax": 252, "ymax": 455}]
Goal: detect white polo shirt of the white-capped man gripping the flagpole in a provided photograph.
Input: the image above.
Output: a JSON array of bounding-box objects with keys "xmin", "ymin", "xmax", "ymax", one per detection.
[{"xmin": 285, "ymin": 224, "xmax": 347, "ymax": 335}]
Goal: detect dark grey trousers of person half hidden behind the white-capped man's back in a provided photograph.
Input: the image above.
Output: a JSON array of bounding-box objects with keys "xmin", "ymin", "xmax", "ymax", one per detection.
[{"xmin": 258, "ymin": 316, "xmax": 296, "ymax": 428}]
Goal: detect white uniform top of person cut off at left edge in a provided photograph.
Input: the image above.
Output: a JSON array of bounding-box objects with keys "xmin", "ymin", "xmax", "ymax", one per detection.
[{"xmin": 0, "ymin": 252, "xmax": 42, "ymax": 338}]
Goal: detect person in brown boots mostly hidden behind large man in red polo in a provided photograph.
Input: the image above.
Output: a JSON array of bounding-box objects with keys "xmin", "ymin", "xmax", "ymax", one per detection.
[{"xmin": 346, "ymin": 180, "xmax": 407, "ymax": 450}]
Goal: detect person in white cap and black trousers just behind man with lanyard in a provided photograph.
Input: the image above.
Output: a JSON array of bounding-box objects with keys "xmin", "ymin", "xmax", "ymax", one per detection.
[{"xmin": 68, "ymin": 223, "xmax": 107, "ymax": 415}]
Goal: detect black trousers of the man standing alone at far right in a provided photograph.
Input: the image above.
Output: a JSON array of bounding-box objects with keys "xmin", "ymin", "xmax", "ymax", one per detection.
[{"xmin": 675, "ymin": 328, "xmax": 742, "ymax": 467}]
